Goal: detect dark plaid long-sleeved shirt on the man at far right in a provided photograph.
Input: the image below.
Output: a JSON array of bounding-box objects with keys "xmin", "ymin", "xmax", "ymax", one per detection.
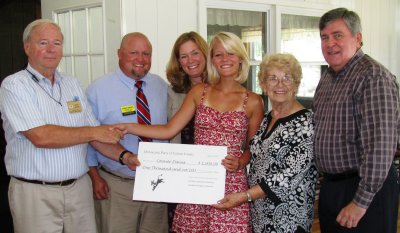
[{"xmin": 313, "ymin": 49, "xmax": 400, "ymax": 208}]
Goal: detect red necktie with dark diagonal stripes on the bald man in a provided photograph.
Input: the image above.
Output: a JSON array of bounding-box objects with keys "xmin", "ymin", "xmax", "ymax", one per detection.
[{"xmin": 135, "ymin": 81, "xmax": 151, "ymax": 142}]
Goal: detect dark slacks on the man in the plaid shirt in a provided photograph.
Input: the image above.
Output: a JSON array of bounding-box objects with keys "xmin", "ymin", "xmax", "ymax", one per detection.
[{"xmin": 318, "ymin": 165, "xmax": 399, "ymax": 233}]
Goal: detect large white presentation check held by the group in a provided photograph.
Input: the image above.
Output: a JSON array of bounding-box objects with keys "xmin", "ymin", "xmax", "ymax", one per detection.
[{"xmin": 133, "ymin": 142, "xmax": 227, "ymax": 205}]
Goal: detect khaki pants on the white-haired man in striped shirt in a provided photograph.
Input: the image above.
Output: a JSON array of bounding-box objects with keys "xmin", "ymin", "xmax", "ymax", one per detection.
[{"xmin": 8, "ymin": 175, "xmax": 96, "ymax": 233}]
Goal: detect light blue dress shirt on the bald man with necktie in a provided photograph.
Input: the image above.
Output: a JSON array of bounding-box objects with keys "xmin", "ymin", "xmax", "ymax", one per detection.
[{"xmin": 86, "ymin": 68, "xmax": 168, "ymax": 177}]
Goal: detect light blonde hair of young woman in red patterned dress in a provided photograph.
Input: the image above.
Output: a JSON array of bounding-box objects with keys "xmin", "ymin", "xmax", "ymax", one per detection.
[{"xmin": 207, "ymin": 32, "xmax": 250, "ymax": 84}]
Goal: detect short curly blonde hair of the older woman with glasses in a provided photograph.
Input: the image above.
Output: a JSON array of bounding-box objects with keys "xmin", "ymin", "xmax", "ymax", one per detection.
[{"xmin": 258, "ymin": 53, "xmax": 303, "ymax": 93}]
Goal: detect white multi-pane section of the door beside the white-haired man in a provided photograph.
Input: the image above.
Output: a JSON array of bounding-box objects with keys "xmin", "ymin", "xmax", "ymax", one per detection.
[{"xmin": 56, "ymin": 6, "xmax": 105, "ymax": 88}]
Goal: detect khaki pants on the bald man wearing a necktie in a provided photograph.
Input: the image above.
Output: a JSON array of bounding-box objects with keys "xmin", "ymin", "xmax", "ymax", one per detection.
[{"xmin": 95, "ymin": 170, "xmax": 168, "ymax": 233}]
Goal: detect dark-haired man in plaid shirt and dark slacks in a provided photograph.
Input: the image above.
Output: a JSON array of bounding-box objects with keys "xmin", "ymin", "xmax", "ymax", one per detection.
[{"xmin": 313, "ymin": 8, "xmax": 400, "ymax": 233}]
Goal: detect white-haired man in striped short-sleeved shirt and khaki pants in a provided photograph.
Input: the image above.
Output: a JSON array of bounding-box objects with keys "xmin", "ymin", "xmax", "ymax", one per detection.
[{"xmin": 0, "ymin": 19, "xmax": 139, "ymax": 233}]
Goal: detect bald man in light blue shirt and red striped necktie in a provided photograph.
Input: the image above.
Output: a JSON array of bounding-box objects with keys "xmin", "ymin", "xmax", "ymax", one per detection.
[{"xmin": 86, "ymin": 32, "xmax": 168, "ymax": 233}]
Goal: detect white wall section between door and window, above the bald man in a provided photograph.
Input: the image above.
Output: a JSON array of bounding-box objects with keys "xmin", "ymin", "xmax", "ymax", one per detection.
[{"xmin": 121, "ymin": 0, "xmax": 198, "ymax": 78}]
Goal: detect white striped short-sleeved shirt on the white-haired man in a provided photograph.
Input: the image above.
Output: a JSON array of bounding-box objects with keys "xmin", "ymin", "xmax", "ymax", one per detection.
[{"xmin": 0, "ymin": 65, "xmax": 99, "ymax": 181}]
